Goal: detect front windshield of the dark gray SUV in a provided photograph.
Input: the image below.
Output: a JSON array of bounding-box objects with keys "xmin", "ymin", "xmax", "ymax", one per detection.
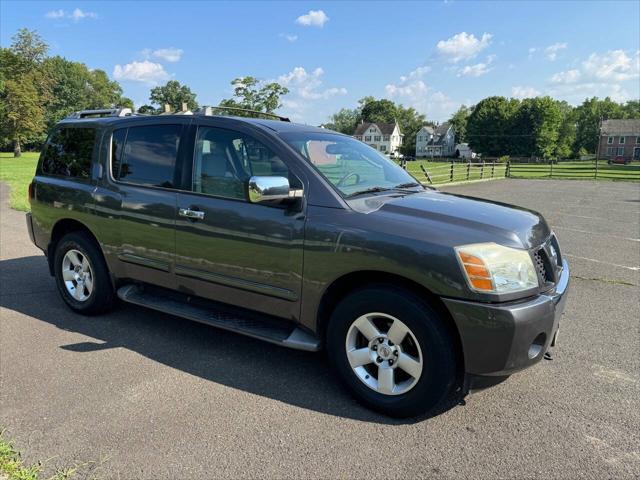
[{"xmin": 281, "ymin": 132, "xmax": 420, "ymax": 196}]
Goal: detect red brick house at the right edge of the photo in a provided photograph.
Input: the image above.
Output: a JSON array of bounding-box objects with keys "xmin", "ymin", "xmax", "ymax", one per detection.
[{"xmin": 598, "ymin": 119, "xmax": 640, "ymax": 161}]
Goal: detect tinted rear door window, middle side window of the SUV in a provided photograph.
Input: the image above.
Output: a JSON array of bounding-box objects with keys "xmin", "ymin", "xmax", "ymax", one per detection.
[{"xmin": 111, "ymin": 125, "xmax": 182, "ymax": 188}]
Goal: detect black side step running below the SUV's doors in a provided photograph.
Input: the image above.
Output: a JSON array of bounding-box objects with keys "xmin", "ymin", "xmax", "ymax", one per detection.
[{"xmin": 118, "ymin": 285, "xmax": 320, "ymax": 352}]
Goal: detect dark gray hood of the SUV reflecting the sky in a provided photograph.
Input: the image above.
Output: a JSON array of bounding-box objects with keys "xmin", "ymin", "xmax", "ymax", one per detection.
[{"xmin": 351, "ymin": 191, "xmax": 551, "ymax": 249}]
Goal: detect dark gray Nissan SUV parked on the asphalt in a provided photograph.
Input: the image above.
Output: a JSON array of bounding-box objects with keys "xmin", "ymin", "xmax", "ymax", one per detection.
[{"xmin": 27, "ymin": 109, "xmax": 569, "ymax": 416}]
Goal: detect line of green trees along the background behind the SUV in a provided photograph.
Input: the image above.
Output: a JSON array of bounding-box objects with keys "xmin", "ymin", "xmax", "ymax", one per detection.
[{"xmin": 0, "ymin": 29, "xmax": 640, "ymax": 158}]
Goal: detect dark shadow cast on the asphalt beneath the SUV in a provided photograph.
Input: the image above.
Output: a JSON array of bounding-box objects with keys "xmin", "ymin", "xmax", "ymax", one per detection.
[{"xmin": 0, "ymin": 256, "xmax": 458, "ymax": 425}]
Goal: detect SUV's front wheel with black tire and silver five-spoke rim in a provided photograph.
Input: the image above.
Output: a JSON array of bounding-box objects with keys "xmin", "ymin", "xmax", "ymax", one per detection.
[{"xmin": 327, "ymin": 285, "xmax": 457, "ymax": 418}]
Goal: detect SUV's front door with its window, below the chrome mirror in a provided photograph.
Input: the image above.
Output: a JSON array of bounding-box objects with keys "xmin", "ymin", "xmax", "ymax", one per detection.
[{"xmin": 176, "ymin": 127, "xmax": 304, "ymax": 318}]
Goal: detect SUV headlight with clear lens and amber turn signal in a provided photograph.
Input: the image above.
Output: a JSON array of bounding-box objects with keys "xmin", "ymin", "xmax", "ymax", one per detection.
[{"xmin": 455, "ymin": 243, "xmax": 538, "ymax": 293}]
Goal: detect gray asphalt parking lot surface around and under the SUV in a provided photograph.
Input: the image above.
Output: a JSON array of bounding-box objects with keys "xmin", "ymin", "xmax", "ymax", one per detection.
[{"xmin": 0, "ymin": 180, "xmax": 640, "ymax": 479}]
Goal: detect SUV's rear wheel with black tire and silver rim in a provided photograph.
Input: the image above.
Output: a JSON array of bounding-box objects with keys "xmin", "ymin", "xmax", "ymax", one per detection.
[{"xmin": 53, "ymin": 232, "xmax": 115, "ymax": 315}]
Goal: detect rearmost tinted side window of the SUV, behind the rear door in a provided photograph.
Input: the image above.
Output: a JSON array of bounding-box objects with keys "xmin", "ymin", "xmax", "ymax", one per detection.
[{"xmin": 42, "ymin": 128, "xmax": 96, "ymax": 178}]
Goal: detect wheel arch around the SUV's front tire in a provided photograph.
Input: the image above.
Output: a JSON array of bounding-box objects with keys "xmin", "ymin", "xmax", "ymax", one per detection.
[{"xmin": 316, "ymin": 270, "xmax": 464, "ymax": 374}]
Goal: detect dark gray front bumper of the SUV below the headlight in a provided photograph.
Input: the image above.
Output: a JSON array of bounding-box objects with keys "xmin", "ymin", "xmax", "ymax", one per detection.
[{"xmin": 443, "ymin": 261, "xmax": 569, "ymax": 377}]
